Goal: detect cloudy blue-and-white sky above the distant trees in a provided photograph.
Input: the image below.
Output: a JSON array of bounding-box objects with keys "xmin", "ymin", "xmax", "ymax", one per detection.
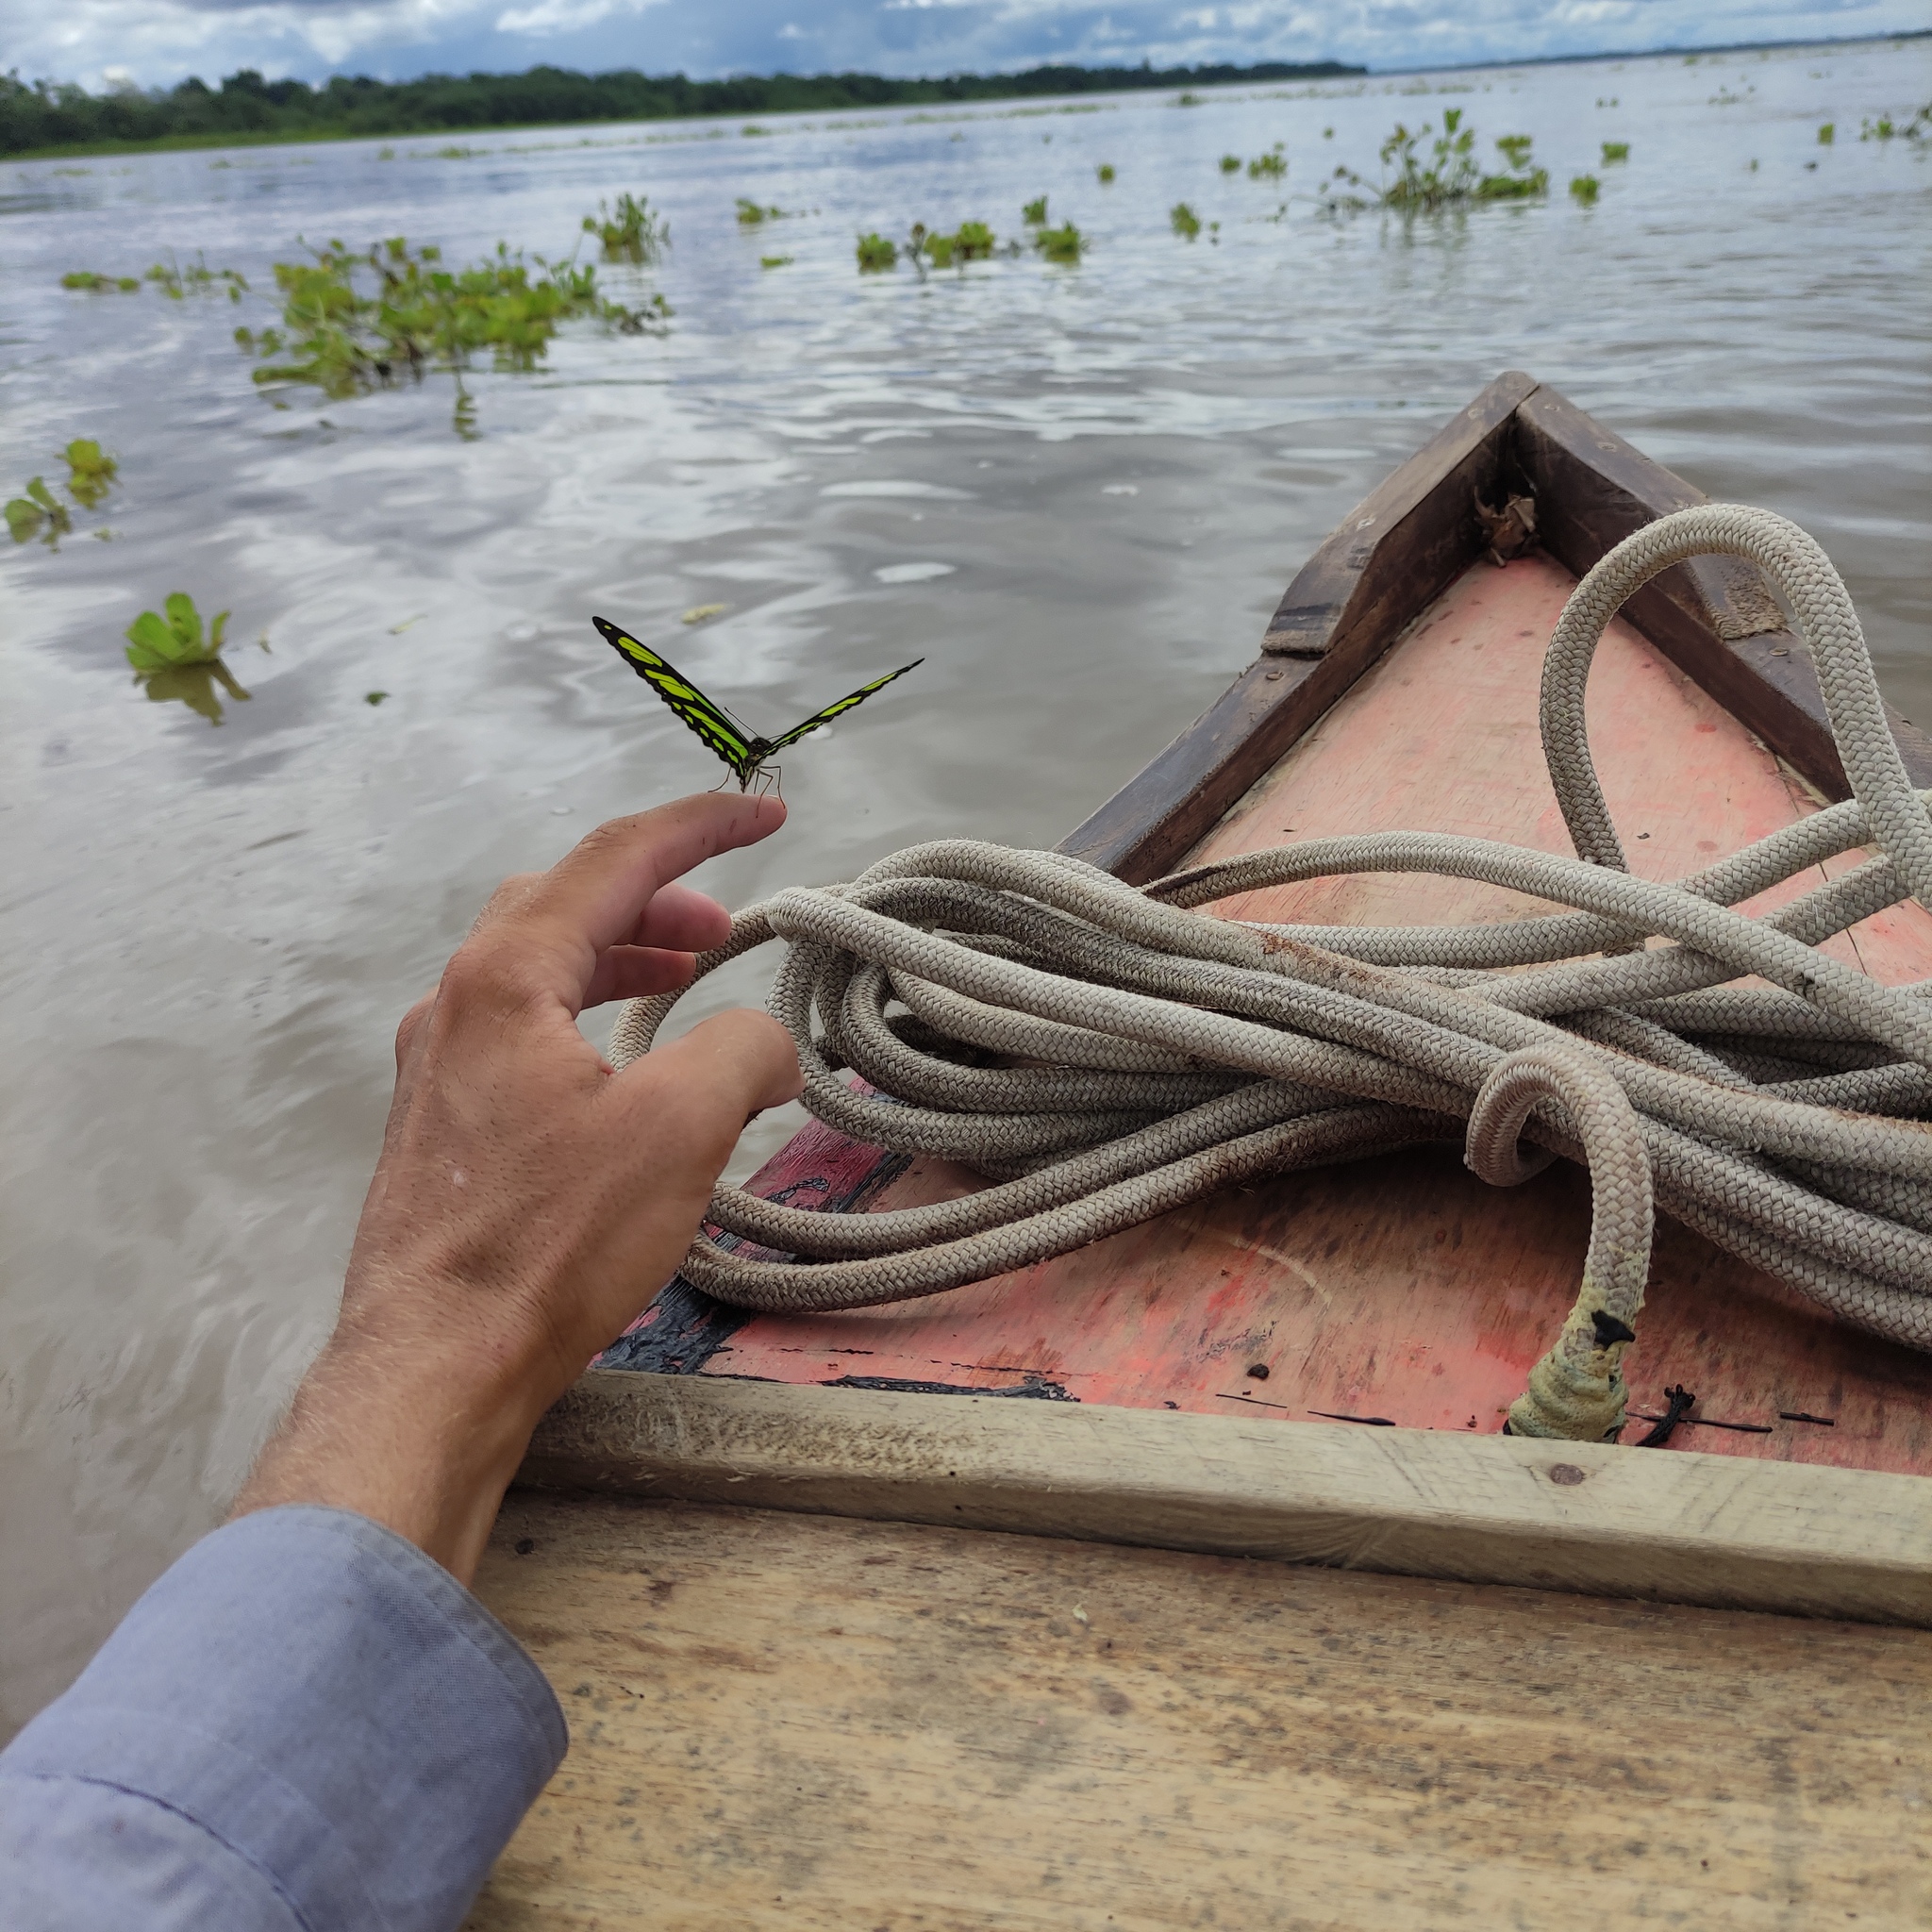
[{"xmin": 0, "ymin": 0, "xmax": 1926, "ymax": 87}]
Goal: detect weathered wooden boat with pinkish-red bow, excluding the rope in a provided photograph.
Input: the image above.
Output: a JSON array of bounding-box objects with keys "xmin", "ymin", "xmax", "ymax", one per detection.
[{"xmin": 474, "ymin": 373, "xmax": 1932, "ymax": 1928}]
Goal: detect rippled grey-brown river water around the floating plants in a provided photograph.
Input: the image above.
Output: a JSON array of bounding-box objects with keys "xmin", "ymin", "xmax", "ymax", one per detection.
[{"xmin": 0, "ymin": 41, "xmax": 1932, "ymax": 1735}]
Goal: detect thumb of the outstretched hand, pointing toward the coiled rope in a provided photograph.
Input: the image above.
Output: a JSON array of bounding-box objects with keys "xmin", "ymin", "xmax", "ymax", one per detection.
[{"xmin": 607, "ymin": 1007, "xmax": 806, "ymax": 1198}]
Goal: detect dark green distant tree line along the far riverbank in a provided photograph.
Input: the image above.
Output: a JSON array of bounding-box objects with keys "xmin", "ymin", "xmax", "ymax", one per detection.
[{"xmin": 0, "ymin": 59, "xmax": 1364, "ymax": 155}]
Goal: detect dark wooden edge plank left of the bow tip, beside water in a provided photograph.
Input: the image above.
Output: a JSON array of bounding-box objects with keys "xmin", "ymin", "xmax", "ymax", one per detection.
[{"xmin": 1060, "ymin": 371, "xmax": 1536, "ymax": 883}]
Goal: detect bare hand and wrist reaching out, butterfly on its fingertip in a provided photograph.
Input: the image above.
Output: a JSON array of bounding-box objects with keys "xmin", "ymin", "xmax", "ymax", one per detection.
[{"xmin": 234, "ymin": 792, "xmax": 802, "ymax": 1582}]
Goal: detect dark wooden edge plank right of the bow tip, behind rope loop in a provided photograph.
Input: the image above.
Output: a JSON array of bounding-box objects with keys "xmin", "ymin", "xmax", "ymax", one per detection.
[{"xmin": 1515, "ymin": 387, "xmax": 1932, "ymax": 798}]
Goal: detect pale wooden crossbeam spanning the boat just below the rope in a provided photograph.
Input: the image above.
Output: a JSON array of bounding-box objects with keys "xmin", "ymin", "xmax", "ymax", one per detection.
[{"xmin": 518, "ymin": 1370, "xmax": 1932, "ymax": 1626}]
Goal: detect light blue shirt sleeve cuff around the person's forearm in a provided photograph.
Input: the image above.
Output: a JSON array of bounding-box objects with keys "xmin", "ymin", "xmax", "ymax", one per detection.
[{"xmin": 0, "ymin": 1507, "xmax": 568, "ymax": 1932}]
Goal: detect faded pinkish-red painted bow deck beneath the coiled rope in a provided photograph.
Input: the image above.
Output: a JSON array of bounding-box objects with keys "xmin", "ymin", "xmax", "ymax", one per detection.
[{"xmin": 605, "ymin": 551, "xmax": 1932, "ymax": 1473}]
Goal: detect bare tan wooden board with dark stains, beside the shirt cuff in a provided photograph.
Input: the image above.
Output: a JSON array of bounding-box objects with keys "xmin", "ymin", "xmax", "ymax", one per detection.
[{"xmin": 468, "ymin": 1495, "xmax": 1932, "ymax": 1932}]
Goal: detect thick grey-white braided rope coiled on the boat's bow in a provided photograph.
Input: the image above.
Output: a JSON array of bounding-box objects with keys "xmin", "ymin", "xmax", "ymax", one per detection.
[{"xmin": 610, "ymin": 505, "xmax": 1932, "ymax": 1440}]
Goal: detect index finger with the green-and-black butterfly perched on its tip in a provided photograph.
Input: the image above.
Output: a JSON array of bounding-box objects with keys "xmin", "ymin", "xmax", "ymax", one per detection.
[{"xmin": 475, "ymin": 792, "xmax": 784, "ymax": 1012}]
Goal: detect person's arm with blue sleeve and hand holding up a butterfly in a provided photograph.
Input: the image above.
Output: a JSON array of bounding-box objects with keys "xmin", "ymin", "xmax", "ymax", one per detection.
[{"xmin": 0, "ymin": 796, "xmax": 800, "ymax": 1932}]
